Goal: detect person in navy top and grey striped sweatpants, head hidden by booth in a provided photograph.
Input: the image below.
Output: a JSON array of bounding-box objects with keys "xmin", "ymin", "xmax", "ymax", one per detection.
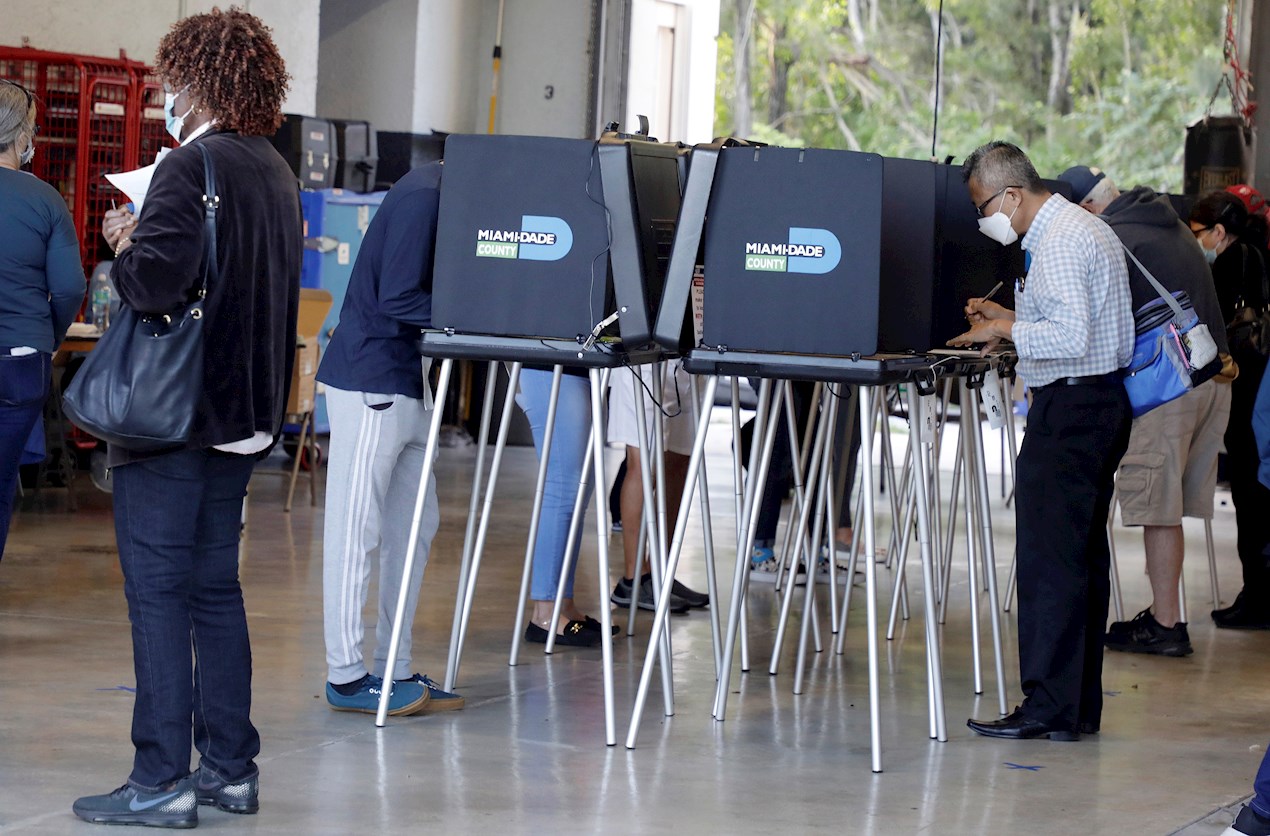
[{"xmin": 318, "ymin": 163, "xmax": 464, "ymax": 715}]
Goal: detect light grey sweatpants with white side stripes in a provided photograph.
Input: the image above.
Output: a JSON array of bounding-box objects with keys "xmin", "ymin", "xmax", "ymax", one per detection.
[{"xmin": 323, "ymin": 386, "xmax": 441, "ymax": 685}]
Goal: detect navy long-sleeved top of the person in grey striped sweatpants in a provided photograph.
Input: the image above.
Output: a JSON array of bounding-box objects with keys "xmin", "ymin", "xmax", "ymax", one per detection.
[{"xmin": 318, "ymin": 163, "xmax": 441, "ymax": 399}]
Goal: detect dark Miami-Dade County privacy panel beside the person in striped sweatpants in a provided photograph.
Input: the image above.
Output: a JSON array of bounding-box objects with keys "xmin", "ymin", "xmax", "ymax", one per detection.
[{"xmin": 432, "ymin": 135, "xmax": 610, "ymax": 339}]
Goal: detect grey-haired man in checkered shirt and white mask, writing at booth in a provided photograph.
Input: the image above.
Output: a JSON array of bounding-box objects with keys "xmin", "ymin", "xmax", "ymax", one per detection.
[{"xmin": 949, "ymin": 141, "xmax": 1134, "ymax": 741}]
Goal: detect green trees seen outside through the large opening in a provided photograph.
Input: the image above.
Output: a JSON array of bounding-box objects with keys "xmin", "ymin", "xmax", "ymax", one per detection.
[{"xmin": 715, "ymin": 0, "xmax": 1229, "ymax": 192}]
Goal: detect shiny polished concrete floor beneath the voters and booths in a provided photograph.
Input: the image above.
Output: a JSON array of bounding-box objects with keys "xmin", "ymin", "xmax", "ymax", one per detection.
[{"xmin": 0, "ymin": 413, "xmax": 1270, "ymax": 836}]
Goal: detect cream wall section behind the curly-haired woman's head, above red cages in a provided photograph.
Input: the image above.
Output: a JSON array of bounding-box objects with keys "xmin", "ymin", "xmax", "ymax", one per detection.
[{"xmin": 0, "ymin": 0, "xmax": 321, "ymax": 113}]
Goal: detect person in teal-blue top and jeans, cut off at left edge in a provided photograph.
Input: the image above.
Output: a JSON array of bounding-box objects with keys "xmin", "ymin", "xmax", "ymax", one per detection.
[{"xmin": 0, "ymin": 80, "xmax": 85, "ymax": 558}]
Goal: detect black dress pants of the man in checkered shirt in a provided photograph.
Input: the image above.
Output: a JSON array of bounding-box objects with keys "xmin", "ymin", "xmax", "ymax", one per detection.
[{"xmin": 1016, "ymin": 380, "xmax": 1132, "ymax": 729}]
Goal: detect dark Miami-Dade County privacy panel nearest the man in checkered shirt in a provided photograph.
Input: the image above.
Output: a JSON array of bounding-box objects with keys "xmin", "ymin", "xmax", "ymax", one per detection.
[{"xmin": 704, "ymin": 147, "xmax": 883, "ymax": 354}]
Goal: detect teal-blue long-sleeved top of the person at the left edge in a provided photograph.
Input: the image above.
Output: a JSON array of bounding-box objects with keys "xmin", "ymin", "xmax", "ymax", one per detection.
[{"xmin": 0, "ymin": 168, "xmax": 84, "ymax": 353}]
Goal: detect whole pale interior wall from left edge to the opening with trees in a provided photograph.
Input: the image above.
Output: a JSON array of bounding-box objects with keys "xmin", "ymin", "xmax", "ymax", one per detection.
[{"xmin": 0, "ymin": 0, "xmax": 719, "ymax": 142}]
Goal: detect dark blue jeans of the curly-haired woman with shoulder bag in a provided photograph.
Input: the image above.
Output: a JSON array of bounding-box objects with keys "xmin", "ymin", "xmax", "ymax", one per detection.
[{"xmin": 112, "ymin": 450, "xmax": 260, "ymax": 792}]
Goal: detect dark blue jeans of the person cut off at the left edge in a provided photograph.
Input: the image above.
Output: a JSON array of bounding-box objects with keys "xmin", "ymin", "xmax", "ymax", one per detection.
[{"xmin": 0, "ymin": 348, "xmax": 52, "ymax": 558}]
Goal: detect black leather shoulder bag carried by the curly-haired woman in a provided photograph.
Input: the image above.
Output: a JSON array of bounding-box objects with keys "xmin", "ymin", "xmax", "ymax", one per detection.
[{"xmin": 62, "ymin": 144, "xmax": 220, "ymax": 452}]
